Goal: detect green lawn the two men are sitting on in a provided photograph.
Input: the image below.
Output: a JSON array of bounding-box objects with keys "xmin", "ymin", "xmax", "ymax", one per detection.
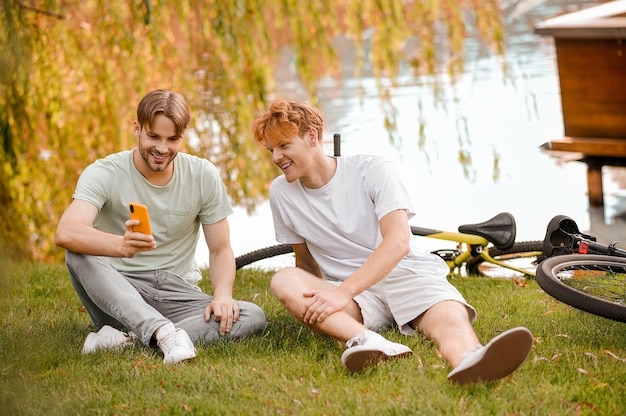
[{"xmin": 0, "ymin": 259, "xmax": 626, "ymax": 415}]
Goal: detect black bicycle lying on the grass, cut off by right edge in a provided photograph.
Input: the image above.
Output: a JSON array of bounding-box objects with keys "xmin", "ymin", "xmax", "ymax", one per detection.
[{"xmin": 536, "ymin": 215, "xmax": 626, "ymax": 322}]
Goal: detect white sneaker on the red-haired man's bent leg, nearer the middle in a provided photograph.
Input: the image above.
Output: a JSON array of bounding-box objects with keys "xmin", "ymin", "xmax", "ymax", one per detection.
[{"xmin": 341, "ymin": 331, "xmax": 413, "ymax": 372}]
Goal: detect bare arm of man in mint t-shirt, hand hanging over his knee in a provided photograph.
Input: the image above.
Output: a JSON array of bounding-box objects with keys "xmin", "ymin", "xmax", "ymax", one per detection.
[{"xmin": 202, "ymin": 218, "xmax": 239, "ymax": 335}]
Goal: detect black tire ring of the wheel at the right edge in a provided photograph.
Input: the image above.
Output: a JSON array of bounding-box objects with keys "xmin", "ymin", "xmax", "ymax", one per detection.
[{"xmin": 537, "ymin": 254, "xmax": 626, "ymax": 322}]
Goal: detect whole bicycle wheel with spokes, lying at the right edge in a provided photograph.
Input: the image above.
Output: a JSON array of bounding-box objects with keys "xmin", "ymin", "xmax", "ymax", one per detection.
[{"xmin": 537, "ymin": 254, "xmax": 626, "ymax": 322}]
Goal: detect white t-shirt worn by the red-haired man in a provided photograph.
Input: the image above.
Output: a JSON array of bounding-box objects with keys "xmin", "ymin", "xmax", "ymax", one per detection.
[{"xmin": 270, "ymin": 155, "xmax": 432, "ymax": 280}]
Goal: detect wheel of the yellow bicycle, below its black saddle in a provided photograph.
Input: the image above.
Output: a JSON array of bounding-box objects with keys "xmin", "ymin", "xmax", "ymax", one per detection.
[{"xmin": 466, "ymin": 241, "xmax": 544, "ymax": 278}]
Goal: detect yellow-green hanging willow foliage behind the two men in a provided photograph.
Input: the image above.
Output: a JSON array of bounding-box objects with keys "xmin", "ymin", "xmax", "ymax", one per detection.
[{"xmin": 0, "ymin": 0, "xmax": 503, "ymax": 261}]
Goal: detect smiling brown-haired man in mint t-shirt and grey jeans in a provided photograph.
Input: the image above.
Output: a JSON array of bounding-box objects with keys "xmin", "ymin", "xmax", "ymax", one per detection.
[{"xmin": 55, "ymin": 90, "xmax": 266, "ymax": 364}]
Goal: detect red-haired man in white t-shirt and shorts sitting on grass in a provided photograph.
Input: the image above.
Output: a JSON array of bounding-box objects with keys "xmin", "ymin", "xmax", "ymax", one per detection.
[{"xmin": 252, "ymin": 100, "xmax": 533, "ymax": 384}]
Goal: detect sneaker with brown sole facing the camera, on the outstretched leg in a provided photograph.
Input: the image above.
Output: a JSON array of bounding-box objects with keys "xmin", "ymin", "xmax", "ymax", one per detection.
[{"xmin": 448, "ymin": 327, "xmax": 533, "ymax": 384}]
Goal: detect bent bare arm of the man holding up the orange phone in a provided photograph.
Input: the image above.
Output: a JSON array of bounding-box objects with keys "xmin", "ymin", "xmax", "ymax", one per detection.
[{"xmin": 54, "ymin": 199, "xmax": 156, "ymax": 257}]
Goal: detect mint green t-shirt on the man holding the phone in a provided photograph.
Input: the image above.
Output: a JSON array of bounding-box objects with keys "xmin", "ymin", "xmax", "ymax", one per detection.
[{"xmin": 73, "ymin": 150, "xmax": 233, "ymax": 285}]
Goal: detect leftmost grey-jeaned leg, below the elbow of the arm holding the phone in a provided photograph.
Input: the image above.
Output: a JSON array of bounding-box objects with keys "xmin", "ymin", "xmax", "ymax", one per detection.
[{"xmin": 66, "ymin": 251, "xmax": 170, "ymax": 346}]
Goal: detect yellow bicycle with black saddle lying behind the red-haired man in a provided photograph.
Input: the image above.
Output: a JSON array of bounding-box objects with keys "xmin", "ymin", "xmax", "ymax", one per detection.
[{"xmin": 235, "ymin": 212, "xmax": 543, "ymax": 279}]
